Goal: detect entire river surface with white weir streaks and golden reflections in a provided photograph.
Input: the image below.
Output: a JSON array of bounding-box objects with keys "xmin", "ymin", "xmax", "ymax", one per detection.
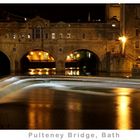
[{"xmin": 0, "ymin": 77, "xmax": 140, "ymax": 130}]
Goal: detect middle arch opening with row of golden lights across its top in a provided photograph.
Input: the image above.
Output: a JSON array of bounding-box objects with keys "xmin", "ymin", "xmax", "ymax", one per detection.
[{"xmin": 21, "ymin": 50, "xmax": 56, "ymax": 75}]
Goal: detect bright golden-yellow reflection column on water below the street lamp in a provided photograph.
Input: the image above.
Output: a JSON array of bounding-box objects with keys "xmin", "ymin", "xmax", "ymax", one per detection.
[{"xmin": 115, "ymin": 88, "xmax": 132, "ymax": 129}]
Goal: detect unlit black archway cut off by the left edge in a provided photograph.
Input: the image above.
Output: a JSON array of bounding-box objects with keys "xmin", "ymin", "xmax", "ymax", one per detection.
[{"xmin": 0, "ymin": 51, "xmax": 10, "ymax": 76}]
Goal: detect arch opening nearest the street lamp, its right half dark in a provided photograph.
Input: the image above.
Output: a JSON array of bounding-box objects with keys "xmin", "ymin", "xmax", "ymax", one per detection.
[{"xmin": 65, "ymin": 49, "xmax": 100, "ymax": 75}]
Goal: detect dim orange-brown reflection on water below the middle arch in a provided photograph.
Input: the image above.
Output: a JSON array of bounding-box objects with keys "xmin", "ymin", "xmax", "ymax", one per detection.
[{"xmin": 28, "ymin": 88, "xmax": 54, "ymax": 129}]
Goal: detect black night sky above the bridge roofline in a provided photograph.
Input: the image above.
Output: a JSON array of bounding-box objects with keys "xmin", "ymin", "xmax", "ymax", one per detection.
[{"xmin": 0, "ymin": 3, "xmax": 105, "ymax": 22}]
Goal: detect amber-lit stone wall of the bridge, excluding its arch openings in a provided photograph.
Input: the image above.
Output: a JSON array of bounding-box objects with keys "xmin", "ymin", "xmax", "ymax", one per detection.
[{"xmin": 0, "ymin": 5, "xmax": 140, "ymax": 74}]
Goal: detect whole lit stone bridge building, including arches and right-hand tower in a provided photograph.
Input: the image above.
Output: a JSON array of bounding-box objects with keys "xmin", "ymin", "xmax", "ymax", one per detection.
[{"xmin": 0, "ymin": 4, "xmax": 140, "ymax": 75}]
